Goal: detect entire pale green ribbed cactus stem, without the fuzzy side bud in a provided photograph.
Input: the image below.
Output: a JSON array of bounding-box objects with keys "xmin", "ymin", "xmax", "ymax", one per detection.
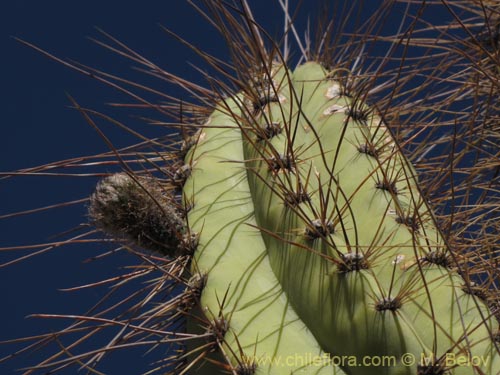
[{"xmin": 184, "ymin": 62, "xmax": 500, "ymax": 374}]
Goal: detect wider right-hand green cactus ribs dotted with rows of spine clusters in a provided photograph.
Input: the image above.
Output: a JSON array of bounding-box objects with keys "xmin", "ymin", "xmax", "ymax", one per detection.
[{"xmin": 242, "ymin": 63, "xmax": 500, "ymax": 375}]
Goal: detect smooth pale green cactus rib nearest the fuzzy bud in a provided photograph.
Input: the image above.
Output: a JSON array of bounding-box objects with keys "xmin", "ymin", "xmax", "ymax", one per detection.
[{"xmin": 183, "ymin": 100, "xmax": 344, "ymax": 375}]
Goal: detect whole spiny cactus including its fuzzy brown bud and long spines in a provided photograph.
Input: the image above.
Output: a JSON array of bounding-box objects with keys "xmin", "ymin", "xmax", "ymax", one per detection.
[{"xmin": 0, "ymin": 1, "xmax": 500, "ymax": 375}]
